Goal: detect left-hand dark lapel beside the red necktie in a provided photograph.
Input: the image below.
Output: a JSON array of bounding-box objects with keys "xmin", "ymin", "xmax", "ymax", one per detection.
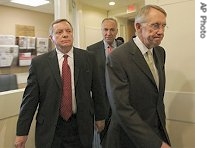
[{"xmin": 48, "ymin": 50, "xmax": 61, "ymax": 88}]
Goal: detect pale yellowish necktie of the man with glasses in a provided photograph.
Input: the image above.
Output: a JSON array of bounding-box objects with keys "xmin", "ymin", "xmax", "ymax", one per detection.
[{"xmin": 145, "ymin": 49, "xmax": 159, "ymax": 87}]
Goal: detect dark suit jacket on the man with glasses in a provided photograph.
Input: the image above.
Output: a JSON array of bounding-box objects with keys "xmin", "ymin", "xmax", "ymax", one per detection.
[{"xmin": 106, "ymin": 40, "xmax": 170, "ymax": 148}]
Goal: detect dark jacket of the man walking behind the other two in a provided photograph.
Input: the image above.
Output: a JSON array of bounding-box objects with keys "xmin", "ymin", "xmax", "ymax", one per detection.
[{"xmin": 87, "ymin": 40, "xmax": 122, "ymax": 117}]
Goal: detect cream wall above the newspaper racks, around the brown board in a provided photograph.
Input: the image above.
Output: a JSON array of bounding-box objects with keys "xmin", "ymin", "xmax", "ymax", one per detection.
[{"xmin": 0, "ymin": 5, "xmax": 53, "ymax": 37}]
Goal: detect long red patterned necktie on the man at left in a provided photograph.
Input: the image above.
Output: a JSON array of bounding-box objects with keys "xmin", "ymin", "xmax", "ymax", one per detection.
[{"xmin": 60, "ymin": 55, "xmax": 72, "ymax": 121}]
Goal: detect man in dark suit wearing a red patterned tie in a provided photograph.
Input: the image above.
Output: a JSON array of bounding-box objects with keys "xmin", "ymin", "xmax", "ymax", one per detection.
[{"xmin": 15, "ymin": 19, "xmax": 105, "ymax": 148}]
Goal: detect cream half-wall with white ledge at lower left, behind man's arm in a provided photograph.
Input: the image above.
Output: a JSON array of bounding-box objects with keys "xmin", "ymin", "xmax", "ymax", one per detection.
[{"xmin": 0, "ymin": 89, "xmax": 35, "ymax": 148}]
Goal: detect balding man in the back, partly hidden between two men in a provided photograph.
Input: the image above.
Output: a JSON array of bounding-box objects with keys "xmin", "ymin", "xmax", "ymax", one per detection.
[{"xmin": 87, "ymin": 18, "xmax": 122, "ymax": 145}]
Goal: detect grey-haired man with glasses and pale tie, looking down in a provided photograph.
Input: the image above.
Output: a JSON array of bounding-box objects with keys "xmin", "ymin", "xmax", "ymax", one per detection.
[{"xmin": 106, "ymin": 5, "xmax": 170, "ymax": 148}]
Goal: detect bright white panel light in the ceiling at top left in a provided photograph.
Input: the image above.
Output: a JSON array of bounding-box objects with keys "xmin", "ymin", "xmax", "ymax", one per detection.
[{"xmin": 11, "ymin": 0, "xmax": 49, "ymax": 7}]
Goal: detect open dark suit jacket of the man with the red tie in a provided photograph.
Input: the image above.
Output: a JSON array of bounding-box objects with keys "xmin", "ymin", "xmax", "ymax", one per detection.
[{"xmin": 17, "ymin": 48, "xmax": 105, "ymax": 148}]
